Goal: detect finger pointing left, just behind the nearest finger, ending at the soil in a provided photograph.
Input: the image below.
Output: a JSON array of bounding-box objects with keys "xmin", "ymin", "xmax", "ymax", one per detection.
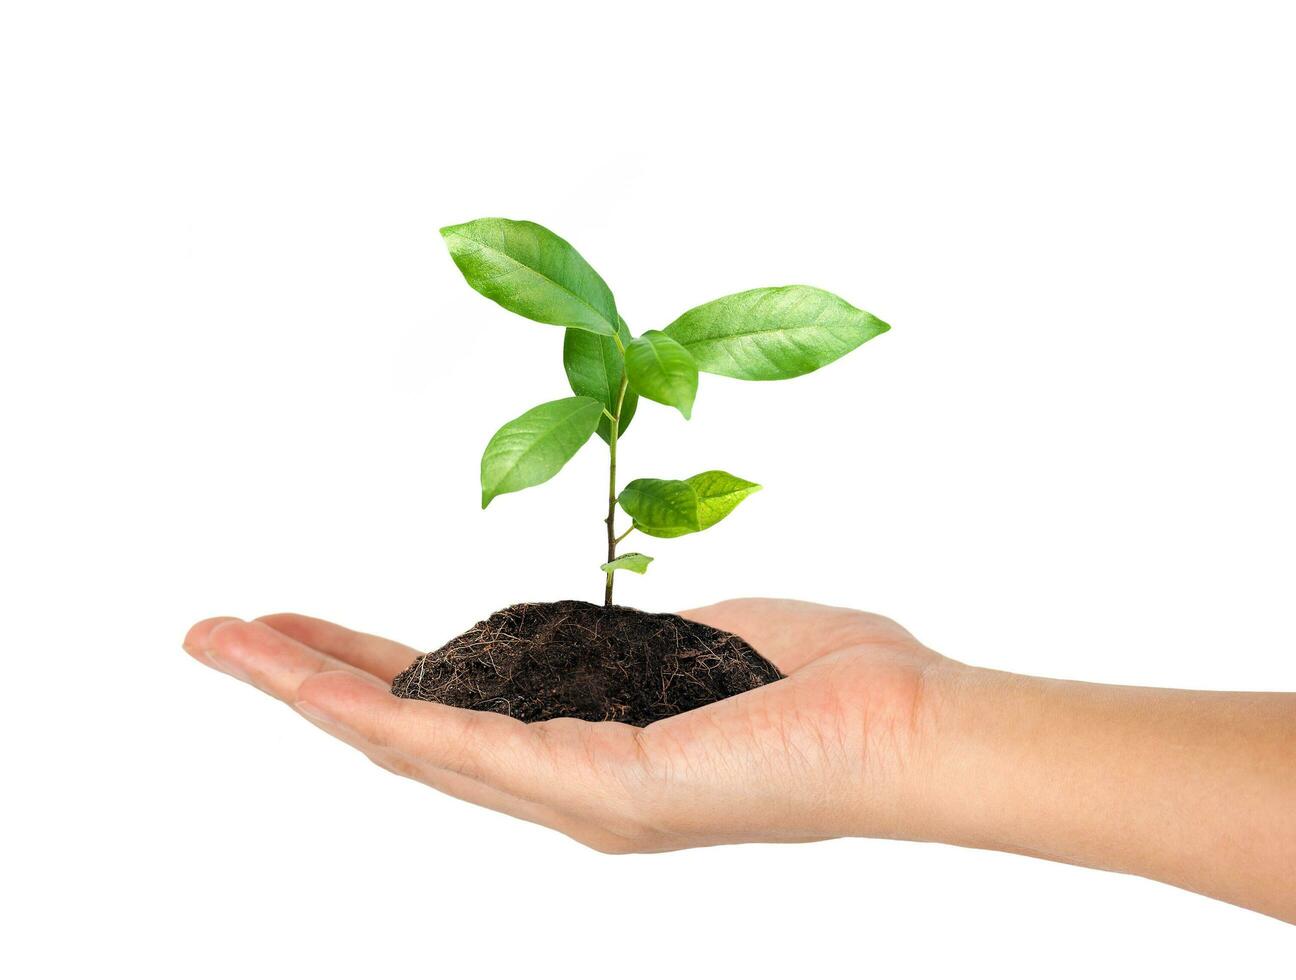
[{"xmin": 198, "ymin": 620, "xmax": 386, "ymax": 703}]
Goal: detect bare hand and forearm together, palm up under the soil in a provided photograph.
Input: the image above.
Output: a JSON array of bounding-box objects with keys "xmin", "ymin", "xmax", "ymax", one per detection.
[{"xmin": 184, "ymin": 599, "xmax": 1296, "ymax": 922}]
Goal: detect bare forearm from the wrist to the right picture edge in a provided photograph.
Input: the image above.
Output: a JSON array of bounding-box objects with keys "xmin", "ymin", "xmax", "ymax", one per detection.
[{"xmin": 920, "ymin": 669, "xmax": 1296, "ymax": 922}]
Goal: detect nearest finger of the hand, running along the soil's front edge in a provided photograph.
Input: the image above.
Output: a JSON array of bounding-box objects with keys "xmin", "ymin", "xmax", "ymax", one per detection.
[{"xmin": 295, "ymin": 673, "xmax": 639, "ymax": 832}]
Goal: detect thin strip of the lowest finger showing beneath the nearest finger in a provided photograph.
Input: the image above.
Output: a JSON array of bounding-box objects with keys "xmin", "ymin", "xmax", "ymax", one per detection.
[{"xmin": 292, "ymin": 712, "xmax": 631, "ymax": 852}]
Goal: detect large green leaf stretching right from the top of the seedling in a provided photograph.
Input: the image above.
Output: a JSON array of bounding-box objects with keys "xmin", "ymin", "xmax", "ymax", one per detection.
[{"xmin": 665, "ymin": 285, "xmax": 890, "ymax": 381}]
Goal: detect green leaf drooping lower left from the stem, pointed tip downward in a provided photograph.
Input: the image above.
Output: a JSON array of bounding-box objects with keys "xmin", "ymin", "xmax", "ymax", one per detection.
[{"xmin": 482, "ymin": 397, "xmax": 603, "ymax": 509}]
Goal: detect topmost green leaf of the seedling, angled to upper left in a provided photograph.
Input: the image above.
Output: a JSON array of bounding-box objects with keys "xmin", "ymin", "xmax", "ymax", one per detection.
[{"xmin": 441, "ymin": 218, "xmax": 617, "ymax": 337}]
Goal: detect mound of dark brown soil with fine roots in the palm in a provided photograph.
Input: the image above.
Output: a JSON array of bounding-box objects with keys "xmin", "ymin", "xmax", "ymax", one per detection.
[{"xmin": 391, "ymin": 599, "xmax": 783, "ymax": 727}]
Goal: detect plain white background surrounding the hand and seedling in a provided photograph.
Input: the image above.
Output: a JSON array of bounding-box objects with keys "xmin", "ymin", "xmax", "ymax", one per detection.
[{"xmin": 0, "ymin": 1, "xmax": 1296, "ymax": 977}]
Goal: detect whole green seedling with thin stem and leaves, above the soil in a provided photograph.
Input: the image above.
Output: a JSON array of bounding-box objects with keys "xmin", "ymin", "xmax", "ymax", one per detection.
[{"xmin": 441, "ymin": 218, "xmax": 889, "ymax": 605}]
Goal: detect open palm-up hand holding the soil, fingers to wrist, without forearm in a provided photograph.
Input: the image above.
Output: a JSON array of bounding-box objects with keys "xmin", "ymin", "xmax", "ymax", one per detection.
[{"xmin": 184, "ymin": 599, "xmax": 958, "ymax": 853}]
